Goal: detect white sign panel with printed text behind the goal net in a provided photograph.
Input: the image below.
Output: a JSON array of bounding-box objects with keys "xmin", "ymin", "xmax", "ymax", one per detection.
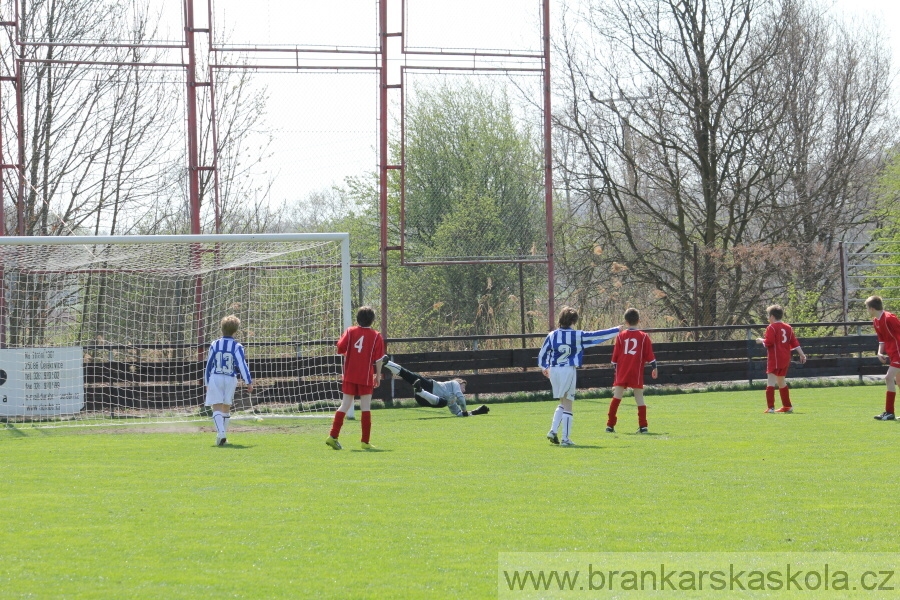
[{"xmin": 0, "ymin": 347, "xmax": 84, "ymax": 417}]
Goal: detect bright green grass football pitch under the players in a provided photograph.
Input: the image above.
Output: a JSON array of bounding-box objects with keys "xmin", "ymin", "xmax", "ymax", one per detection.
[{"xmin": 0, "ymin": 386, "xmax": 900, "ymax": 598}]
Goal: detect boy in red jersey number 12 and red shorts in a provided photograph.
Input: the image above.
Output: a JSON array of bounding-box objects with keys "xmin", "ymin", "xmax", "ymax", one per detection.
[{"xmin": 606, "ymin": 308, "xmax": 658, "ymax": 433}]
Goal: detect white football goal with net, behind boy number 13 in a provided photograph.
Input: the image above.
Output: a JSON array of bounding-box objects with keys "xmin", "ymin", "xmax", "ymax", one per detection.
[{"xmin": 0, "ymin": 234, "xmax": 350, "ymax": 425}]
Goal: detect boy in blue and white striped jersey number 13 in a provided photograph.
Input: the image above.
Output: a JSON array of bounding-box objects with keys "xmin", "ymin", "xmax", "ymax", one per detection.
[{"xmin": 203, "ymin": 315, "xmax": 253, "ymax": 446}]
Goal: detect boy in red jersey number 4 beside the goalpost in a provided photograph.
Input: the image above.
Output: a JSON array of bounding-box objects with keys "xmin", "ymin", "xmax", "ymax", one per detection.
[{"xmin": 325, "ymin": 306, "xmax": 385, "ymax": 450}]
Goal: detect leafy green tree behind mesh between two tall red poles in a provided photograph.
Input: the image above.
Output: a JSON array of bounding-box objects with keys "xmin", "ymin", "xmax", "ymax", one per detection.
[{"xmin": 390, "ymin": 80, "xmax": 546, "ymax": 335}]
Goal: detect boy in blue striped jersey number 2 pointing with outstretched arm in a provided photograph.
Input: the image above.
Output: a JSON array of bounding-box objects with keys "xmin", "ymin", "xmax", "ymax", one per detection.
[{"xmin": 538, "ymin": 306, "xmax": 622, "ymax": 446}]
